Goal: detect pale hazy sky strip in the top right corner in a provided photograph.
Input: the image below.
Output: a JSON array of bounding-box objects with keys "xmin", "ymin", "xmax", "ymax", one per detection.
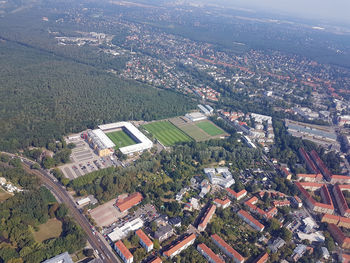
[{"xmin": 208, "ymin": 0, "xmax": 350, "ymax": 24}]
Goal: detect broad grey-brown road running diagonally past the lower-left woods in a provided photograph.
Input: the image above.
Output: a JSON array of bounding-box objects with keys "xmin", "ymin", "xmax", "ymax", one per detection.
[{"xmin": 0, "ymin": 153, "xmax": 121, "ymax": 263}]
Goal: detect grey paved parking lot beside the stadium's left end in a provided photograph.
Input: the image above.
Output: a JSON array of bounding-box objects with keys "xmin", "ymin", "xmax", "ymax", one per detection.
[{"xmin": 59, "ymin": 135, "xmax": 117, "ymax": 180}]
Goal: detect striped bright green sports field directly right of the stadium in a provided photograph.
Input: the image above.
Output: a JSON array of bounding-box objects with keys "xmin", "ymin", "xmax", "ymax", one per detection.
[{"xmin": 143, "ymin": 121, "xmax": 192, "ymax": 146}]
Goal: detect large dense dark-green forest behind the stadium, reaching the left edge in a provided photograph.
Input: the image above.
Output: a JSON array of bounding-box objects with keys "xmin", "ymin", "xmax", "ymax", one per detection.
[{"xmin": 0, "ymin": 40, "xmax": 194, "ymax": 154}]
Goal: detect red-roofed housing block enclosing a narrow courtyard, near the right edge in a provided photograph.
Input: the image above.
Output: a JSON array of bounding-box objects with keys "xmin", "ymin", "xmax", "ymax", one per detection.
[{"xmin": 295, "ymin": 182, "xmax": 334, "ymax": 214}]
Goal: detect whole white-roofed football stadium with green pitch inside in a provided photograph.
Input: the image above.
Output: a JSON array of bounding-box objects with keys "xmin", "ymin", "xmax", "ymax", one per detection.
[{"xmin": 87, "ymin": 122, "xmax": 153, "ymax": 157}]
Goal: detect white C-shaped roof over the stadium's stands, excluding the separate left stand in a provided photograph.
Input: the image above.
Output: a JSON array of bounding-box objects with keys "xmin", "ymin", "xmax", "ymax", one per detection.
[{"xmin": 98, "ymin": 122, "xmax": 153, "ymax": 155}]
